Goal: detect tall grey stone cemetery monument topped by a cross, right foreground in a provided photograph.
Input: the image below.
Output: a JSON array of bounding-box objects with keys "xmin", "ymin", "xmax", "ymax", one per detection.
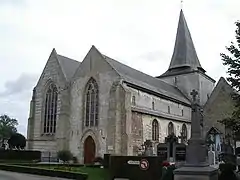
[{"xmin": 174, "ymin": 90, "xmax": 218, "ymax": 180}]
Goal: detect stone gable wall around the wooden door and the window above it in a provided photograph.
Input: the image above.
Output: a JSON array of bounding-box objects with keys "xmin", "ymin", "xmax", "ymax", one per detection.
[{"xmin": 69, "ymin": 48, "xmax": 119, "ymax": 162}]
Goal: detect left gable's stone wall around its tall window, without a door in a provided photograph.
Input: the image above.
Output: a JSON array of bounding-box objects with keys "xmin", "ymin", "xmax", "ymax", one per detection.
[{"xmin": 29, "ymin": 51, "xmax": 68, "ymax": 151}]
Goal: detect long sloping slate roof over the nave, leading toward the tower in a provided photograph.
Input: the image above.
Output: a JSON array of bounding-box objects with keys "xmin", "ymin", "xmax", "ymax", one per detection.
[{"xmin": 103, "ymin": 55, "xmax": 190, "ymax": 104}]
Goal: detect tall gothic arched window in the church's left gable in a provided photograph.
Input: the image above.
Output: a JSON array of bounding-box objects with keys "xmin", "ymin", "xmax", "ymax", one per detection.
[{"xmin": 43, "ymin": 84, "xmax": 58, "ymax": 134}]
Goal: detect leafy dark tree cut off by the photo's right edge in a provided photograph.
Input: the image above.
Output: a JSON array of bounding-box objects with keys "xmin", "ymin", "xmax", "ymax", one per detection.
[{"xmin": 219, "ymin": 21, "xmax": 240, "ymax": 137}]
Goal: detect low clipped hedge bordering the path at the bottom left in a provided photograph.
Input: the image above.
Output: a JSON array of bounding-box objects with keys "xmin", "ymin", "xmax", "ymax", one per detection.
[{"xmin": 0, "ymin": 164, "xmax": 88, "ymax": 180}]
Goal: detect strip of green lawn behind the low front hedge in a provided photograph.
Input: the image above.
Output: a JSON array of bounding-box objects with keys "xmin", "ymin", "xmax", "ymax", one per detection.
[{"xmin": 31, "ymin": 165, "xmax": 108, "ymax": 180}]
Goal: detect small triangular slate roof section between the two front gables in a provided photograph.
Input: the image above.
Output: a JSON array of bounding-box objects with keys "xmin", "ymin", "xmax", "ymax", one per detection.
[{"xmin": 57, "ymin": 54, "xmax": 81, "ymax": 81}]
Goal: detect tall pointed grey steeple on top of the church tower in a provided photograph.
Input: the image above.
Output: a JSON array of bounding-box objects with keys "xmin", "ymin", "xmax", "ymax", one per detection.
[{"xmin": 168, "ymin": 9, "xmax": 205, "ymax": 72}]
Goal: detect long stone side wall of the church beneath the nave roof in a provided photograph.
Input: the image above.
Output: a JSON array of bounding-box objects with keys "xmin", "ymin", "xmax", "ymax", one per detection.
[{"xmin": 127, "ymin": 87, "xmax": 191, "ymax": 155}]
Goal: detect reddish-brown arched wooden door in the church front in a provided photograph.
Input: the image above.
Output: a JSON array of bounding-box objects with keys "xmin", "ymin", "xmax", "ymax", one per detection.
[{"xmin": 84, "ymin": 136, "xmax": 96, "ymax": 164}]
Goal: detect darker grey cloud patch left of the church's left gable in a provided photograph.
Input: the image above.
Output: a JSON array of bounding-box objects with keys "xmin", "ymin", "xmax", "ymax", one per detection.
[{"xmin": 0, "ymin": 73, "xmax": 37, "ymax": 97}]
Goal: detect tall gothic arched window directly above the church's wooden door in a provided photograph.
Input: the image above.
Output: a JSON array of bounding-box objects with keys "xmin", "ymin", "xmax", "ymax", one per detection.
[{"xmin": 85, "ymin": 78, "xmax": 98, "ymax": 127}]
